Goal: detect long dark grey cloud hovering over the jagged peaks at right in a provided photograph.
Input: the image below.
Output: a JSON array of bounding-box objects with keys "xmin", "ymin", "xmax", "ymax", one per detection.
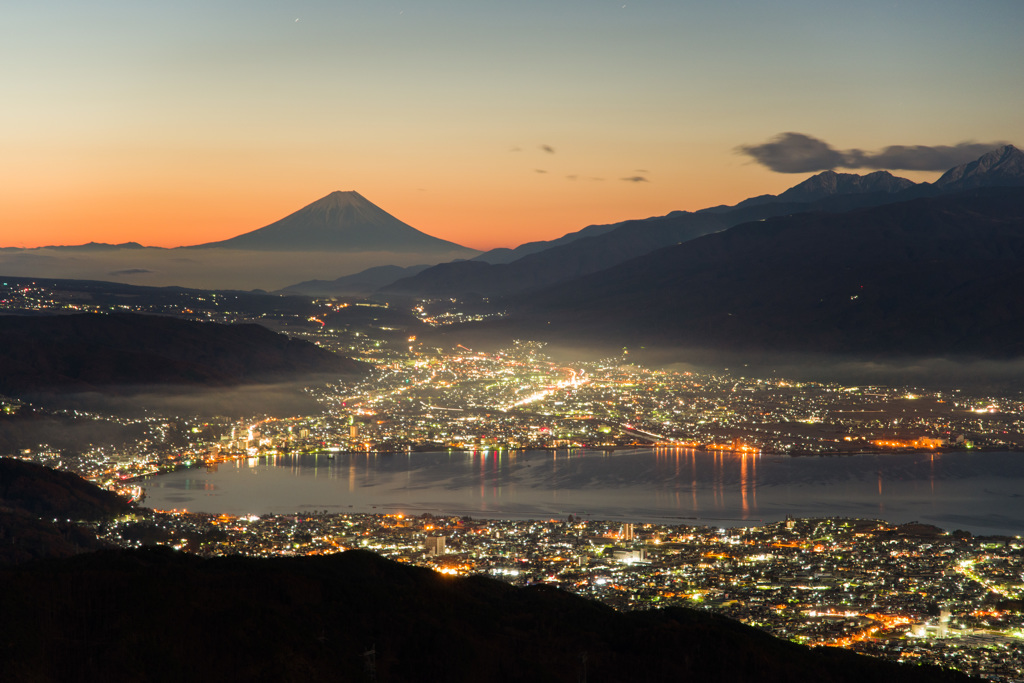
[{"xmin": 736, "ymin": 132, "xmax": 1006, "ymax": 173}]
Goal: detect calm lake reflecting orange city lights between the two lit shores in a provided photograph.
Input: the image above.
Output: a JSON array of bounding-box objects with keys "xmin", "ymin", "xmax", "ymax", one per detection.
[{"xmin": 144, "ymin": 449, "xmax": 1024, "ymax": 536}]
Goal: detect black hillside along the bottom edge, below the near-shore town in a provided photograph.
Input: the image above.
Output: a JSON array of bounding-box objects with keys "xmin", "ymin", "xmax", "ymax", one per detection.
[{"xmin": 0, "ymin": 549, "xmax": 969, "ymax": 683}]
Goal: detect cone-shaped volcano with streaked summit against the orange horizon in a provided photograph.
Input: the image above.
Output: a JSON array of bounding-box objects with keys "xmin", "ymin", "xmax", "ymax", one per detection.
[{"xmin": 185, "ymin": 191, "xmax": 478, "ymax": 258}]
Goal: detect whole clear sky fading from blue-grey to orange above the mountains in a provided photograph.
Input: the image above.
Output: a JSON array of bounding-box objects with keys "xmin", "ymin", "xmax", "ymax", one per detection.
[{"xmin": 0, "ymin": 0, "xmax": 1024, "ymax": 249}]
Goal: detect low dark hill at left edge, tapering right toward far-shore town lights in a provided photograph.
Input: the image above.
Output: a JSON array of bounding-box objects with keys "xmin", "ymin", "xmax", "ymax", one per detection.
[{"xmin": 0, "ymin": 313, "xmax": 360, "ymax": 395}]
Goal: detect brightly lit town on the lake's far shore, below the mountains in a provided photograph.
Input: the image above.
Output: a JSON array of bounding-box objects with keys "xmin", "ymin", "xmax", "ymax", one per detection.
[{"xmin": 3, "ymin": 342, "xmax": 1024, "ymax": 501}]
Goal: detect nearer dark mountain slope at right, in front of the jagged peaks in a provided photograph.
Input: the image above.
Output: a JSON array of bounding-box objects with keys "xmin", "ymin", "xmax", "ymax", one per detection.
[{"xmin": 512, "ymin": 187, "xmax": 1024, "ymax": 357}]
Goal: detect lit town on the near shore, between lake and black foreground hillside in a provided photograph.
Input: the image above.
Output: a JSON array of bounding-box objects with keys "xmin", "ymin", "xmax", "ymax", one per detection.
[{"xmin": 88, "ymin": 512, "xmax": 1024, "ymax": 680}]
